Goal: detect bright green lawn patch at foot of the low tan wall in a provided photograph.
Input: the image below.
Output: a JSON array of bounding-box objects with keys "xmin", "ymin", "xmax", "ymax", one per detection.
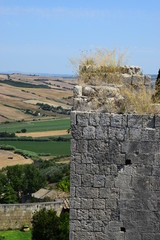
[{"xmin": 0, "ymin": 230, "xmax": 32, "ymax": 240}]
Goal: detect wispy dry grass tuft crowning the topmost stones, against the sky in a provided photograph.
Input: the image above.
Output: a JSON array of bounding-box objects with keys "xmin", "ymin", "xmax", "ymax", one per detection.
[{"xmin": 71, "ymin": 48, "xmax": 126, "ymax": 85}]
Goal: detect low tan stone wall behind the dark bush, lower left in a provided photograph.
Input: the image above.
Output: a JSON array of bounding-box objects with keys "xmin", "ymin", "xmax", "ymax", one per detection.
[{"xmin": 0, "ymin": 201, "xmax": 64, "ymax": 230}]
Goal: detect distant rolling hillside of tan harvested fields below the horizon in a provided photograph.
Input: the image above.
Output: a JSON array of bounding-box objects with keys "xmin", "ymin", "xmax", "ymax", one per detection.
[{"xmin": 0, "ymin": 74, "xmax": 76, "ymax": 122}]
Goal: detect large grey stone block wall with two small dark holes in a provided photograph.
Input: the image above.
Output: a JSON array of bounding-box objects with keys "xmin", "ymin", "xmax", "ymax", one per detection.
[{"xmin": 70, "ymin": 111, "xmax": 160, "ymax": 240}]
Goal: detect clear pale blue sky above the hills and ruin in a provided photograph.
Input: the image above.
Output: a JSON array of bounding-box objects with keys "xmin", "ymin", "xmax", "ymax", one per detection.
[{"xmin": 0, "ymin": 0, "xmax": 160, "ymax": 74}]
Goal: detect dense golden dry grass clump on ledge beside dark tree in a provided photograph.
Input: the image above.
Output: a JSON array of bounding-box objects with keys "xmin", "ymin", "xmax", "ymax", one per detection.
[{"xmin": 119, "ymin": 85, "xmax": 155, "ymax": 114}]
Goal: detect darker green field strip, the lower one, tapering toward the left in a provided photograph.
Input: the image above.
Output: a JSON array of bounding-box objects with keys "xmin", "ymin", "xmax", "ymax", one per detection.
[{"xmin": 0, "ymin": 140, "xmax": 70, "ymax": 156}]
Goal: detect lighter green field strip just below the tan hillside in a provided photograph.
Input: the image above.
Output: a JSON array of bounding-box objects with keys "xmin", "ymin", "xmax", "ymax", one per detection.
[{"xmin": 0, "ymin": 118, "xmax": 70, "ymax": 133}]
